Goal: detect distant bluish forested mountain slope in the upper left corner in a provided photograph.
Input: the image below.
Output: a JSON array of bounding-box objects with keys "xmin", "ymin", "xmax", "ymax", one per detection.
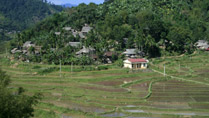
[{"xmin": 0, "ymin": 0, "xmax": 63, "ymax": 41}]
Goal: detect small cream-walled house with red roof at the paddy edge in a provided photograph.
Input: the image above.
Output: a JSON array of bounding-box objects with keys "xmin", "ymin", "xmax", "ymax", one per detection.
[{"xmin": 123, "ymin": 58, "xmax": 149, "ymax": 69}]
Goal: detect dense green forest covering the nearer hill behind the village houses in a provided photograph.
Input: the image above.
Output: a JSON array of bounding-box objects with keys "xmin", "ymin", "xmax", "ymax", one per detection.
[{"xmin": 11, "ymin": 0, "xmax": 209, "ymax": 63}]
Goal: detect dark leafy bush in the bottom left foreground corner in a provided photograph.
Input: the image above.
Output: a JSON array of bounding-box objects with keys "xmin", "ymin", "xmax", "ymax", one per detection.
[{"xmin": 0, "ymin": 69, "xmax": 40, "ymax": 118}]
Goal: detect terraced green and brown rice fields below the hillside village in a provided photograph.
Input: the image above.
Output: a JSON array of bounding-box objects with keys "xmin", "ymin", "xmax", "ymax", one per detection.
[{"xmin": 0, "ymin": 52, "xmax": 209, "ymax": 118}]
